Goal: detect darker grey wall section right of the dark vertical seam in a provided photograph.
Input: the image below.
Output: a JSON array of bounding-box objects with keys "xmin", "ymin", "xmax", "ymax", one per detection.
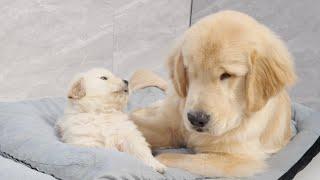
[{"xmin": 192, "ymin": 0, "xmax": 320, "ymax": 110}]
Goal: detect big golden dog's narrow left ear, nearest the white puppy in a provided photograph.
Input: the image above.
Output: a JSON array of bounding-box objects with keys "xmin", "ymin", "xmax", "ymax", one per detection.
[{"xmin": 168, "ymin": 45, "xmax": 188, "ymax": 97}]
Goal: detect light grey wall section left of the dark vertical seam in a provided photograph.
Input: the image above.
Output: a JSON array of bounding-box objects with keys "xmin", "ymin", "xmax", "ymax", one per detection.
[{"xmin": 0, "ymin": 0, "xmax": 191, "ymax": 101}]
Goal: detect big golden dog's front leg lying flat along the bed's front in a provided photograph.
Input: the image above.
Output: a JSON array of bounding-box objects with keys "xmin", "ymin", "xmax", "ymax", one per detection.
[{"xmin": 156, "ymin": 153, "xmax": 265, "ymax": 177}]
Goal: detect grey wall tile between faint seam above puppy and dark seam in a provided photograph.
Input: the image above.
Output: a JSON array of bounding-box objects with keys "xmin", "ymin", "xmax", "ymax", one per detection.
[{"xmin": 113, "ymin": 0, "xmax": 191, "ymax": 77}]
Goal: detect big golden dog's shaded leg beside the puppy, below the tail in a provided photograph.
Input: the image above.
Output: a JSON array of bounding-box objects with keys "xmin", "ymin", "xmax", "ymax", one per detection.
[{"xmin": 130, "ymin": 97, "xmax": 183, "ymax": 149}]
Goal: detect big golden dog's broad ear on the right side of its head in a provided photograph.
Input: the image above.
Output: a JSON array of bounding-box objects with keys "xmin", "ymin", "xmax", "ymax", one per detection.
[{"xmin": 246, "ymin": 33, "xmax": 296, "ymax": 112}]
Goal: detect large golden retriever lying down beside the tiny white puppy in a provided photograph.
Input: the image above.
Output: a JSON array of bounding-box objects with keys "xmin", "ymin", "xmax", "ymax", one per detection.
[{"xmin": 131, "ymin": 11, "xmax": 296, "ymax": 177}]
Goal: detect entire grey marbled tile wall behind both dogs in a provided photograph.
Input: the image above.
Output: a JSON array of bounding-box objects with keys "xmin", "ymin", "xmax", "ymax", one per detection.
[{"xmin": 0, "ymin": 0, "xmax": 320, "ymax": 110}]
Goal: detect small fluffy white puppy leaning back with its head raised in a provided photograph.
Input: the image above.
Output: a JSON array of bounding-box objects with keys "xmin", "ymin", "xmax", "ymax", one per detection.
[{"xmin": 56, "ymin": 69, "xmax": 165, "ymax": 173}]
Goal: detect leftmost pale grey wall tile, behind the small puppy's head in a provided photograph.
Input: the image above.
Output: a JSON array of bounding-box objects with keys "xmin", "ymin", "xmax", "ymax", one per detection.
[{"xmin": 0, "ymin": 0, "xmax": 114, "ymax": 100}]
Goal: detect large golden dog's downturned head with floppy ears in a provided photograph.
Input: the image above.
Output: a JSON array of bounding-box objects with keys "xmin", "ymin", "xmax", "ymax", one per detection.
[{"xmin": 168, "ymin": 11, "xmax": 295, "ymax": 136}]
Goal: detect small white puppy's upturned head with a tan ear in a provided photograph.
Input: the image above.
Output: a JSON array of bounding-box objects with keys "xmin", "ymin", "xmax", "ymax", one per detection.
[{"xmin": 68, "ymin": 68, "xmax": 128, "ymax": 111}]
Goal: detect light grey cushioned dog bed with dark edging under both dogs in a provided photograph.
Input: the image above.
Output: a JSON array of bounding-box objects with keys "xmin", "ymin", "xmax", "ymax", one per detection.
[{"xmin": 0, "ymin": 87, "xmax": 320, "ymax": 180}]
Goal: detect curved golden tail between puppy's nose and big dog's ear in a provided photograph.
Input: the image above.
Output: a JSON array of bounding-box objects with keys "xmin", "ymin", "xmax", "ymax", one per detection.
[{"xmin": 129, "ymin": 69, "xmax": 168, "ymax": 92}]
